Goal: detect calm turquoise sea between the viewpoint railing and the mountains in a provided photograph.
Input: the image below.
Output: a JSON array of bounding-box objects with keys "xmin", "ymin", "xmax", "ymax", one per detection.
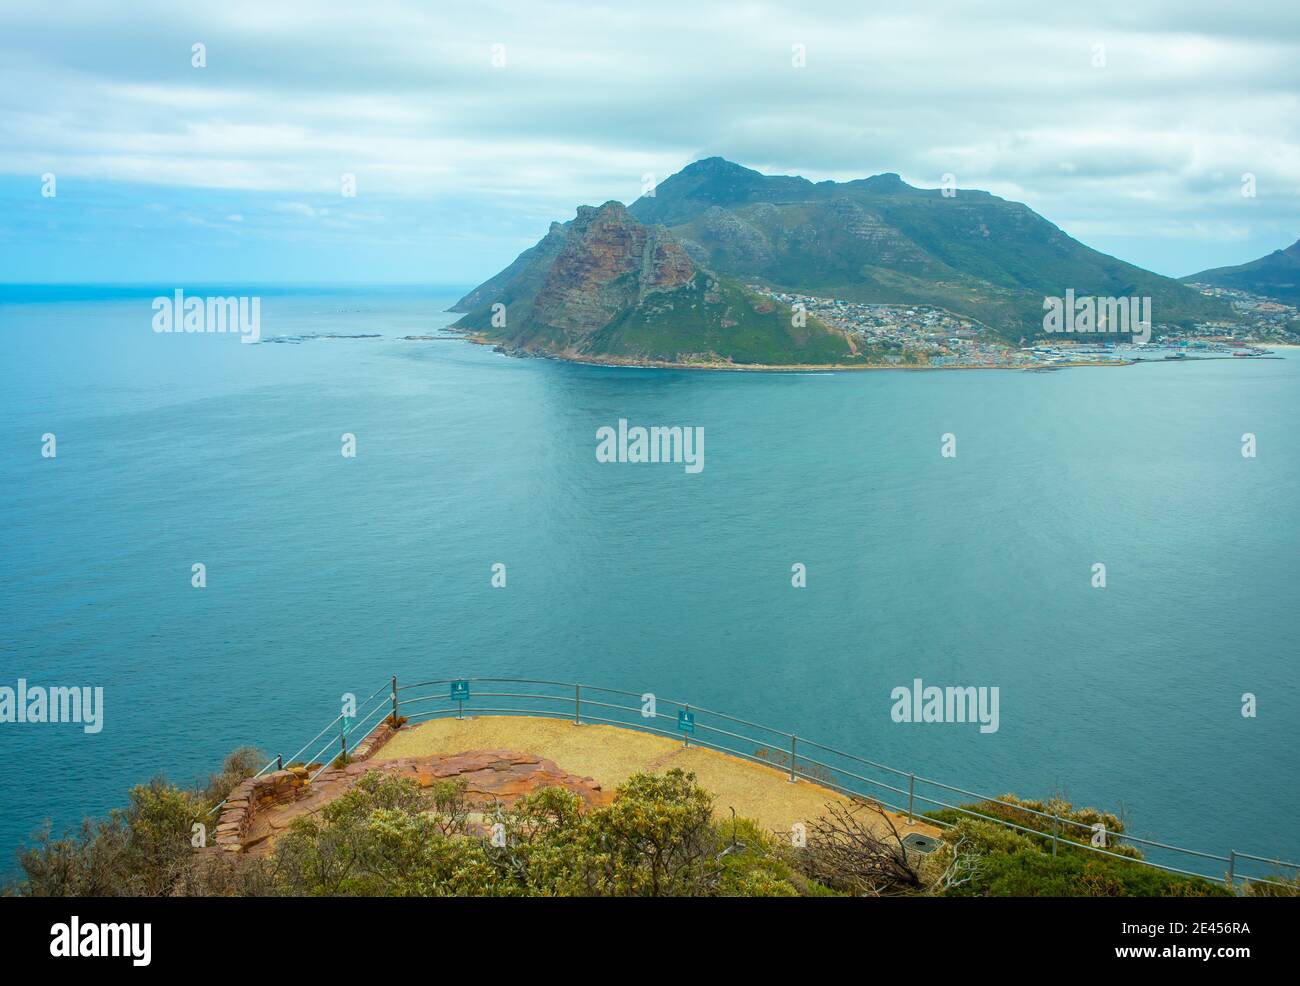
[{"xmin": 0, "ymin": 287, "xmax": 1300, "ymax": 870}]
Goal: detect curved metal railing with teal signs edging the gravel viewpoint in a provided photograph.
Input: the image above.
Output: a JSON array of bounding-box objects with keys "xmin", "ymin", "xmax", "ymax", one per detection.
[{"xmin": 212, "ymin": 675, "xmax": 1300, "ymax": 890}]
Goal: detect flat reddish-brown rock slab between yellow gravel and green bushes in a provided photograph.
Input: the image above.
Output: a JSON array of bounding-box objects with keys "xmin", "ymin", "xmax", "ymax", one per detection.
[{"xmin": 243, "ymin": 749, "xmax": 614, "ymax": 855}]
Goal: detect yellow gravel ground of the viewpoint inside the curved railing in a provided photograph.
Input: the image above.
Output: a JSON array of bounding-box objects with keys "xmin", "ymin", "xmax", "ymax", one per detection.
[{"xmin": 373, "ymin": 715, "xmax": 939, "ymax": 835}]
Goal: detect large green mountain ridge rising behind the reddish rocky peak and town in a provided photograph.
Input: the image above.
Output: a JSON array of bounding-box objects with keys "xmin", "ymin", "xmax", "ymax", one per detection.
[{"xmin": 629, "ymin": 157, "xmax": 1229, "ymax": 340}]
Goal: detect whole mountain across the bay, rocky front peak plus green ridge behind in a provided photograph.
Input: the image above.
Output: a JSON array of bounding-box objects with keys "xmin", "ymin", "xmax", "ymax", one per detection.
[{"xmin": 452, "ymin": 157, "xmax": 1231, "ymax": 364}]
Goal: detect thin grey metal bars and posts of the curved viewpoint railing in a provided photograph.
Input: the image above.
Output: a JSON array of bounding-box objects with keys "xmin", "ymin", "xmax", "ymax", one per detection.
[{"xmin": 223, "ymin": 676, "xmax": 1300, "ymax": 890}]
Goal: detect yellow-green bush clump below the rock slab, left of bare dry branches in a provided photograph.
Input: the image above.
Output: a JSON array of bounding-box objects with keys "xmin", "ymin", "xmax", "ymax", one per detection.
[{"xmin": 252, "ymin": 770, "xmax": 822, "ymax": 896}]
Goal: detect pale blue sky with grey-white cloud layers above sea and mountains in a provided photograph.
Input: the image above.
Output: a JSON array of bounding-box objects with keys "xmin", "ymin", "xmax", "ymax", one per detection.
[{"xmin": 0, "ymin": 0, "xmax": 1300, "ymax": 285}]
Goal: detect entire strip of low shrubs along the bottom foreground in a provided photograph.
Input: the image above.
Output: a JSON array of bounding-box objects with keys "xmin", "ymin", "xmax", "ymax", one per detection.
[{"xmin": 8, "ymin": 751, "xmax": 1248, "ymax": 896}]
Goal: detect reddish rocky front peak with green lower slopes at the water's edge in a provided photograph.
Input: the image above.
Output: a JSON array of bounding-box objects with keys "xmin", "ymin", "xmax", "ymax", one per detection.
[{"xmin": 452, "ymin": 202, "xmax": 852, "ymax": 364}]
